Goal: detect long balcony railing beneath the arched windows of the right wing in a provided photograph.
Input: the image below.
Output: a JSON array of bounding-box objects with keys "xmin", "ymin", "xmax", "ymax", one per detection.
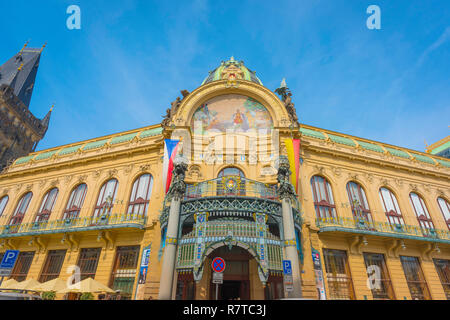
[{"xmin": 316, "ymin": 217, "xmax": 450, "ymax": 242}]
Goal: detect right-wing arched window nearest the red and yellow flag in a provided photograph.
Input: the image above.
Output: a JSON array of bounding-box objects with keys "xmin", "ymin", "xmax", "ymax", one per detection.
[{"xmin": 311, "ymin": 176, "xmax": 337, "ymax": 218}]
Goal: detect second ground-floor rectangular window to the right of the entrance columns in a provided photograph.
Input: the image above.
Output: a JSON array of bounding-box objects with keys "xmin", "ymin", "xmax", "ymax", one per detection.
[{"xmin": 363, "ymin": 252, "xmax": 395, "ymax": 300}]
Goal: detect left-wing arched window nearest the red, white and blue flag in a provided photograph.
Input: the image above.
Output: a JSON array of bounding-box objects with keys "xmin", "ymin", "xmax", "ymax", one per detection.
[{"xmin": 127, "ymin": 173, "xmax": 153, "ymax": 216}]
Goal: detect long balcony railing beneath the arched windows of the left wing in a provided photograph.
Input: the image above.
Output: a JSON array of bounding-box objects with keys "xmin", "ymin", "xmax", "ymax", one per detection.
[{"xmin": 0, "ymin": 214, "xmax": 147, "ymax": 238}]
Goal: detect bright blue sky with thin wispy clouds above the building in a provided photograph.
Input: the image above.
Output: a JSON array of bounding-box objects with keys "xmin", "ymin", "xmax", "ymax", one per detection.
[{"xmin": 0, "ymin": 0, "xmax": 450, "ymax": 151}]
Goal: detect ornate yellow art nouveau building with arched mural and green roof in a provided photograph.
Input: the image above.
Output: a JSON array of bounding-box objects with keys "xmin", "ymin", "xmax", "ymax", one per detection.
[{"xmin": 0, "ymin": 59, "xmax": 450, "ymax": 300}]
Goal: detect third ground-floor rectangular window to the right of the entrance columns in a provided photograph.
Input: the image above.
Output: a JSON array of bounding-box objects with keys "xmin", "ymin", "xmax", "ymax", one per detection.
[{"xmin": 400, "ymin": 256, "xmax": 431, "ymax": 300}]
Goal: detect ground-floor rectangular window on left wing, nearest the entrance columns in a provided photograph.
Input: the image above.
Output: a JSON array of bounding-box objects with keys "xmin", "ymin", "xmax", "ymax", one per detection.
[{"xmin": 110, "ymin": 246, "xmax": 140, "ymax": 300}]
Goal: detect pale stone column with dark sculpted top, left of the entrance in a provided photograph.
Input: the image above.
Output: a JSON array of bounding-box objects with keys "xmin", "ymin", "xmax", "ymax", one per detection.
[{"xmin": 158, "ymin": 162, "xmax": 187, "ymax": 300}]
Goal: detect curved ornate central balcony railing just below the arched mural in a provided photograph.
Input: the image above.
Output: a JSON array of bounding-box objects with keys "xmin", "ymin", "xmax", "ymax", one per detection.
[{"xmin": 184, "ymin": 176, "xmax": 278, "ymax": 200}]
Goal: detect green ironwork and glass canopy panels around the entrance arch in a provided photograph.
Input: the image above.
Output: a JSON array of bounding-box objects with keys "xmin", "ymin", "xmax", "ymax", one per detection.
[{"xmin": 177, "ymin": 221, "xmax": 283, "ymax": 270}]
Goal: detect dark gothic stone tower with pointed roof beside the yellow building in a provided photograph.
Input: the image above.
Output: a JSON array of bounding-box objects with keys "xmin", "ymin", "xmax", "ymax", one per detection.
[{"xmin": 0, "ymin": 45, "xmax": 51, "ymax": 170}]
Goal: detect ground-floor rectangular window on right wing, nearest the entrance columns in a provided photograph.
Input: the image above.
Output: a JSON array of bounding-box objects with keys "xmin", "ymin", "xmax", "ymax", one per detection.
[{"xmin": 323, "ymin": 249, "xmax": 355, "ymax": 300}]
